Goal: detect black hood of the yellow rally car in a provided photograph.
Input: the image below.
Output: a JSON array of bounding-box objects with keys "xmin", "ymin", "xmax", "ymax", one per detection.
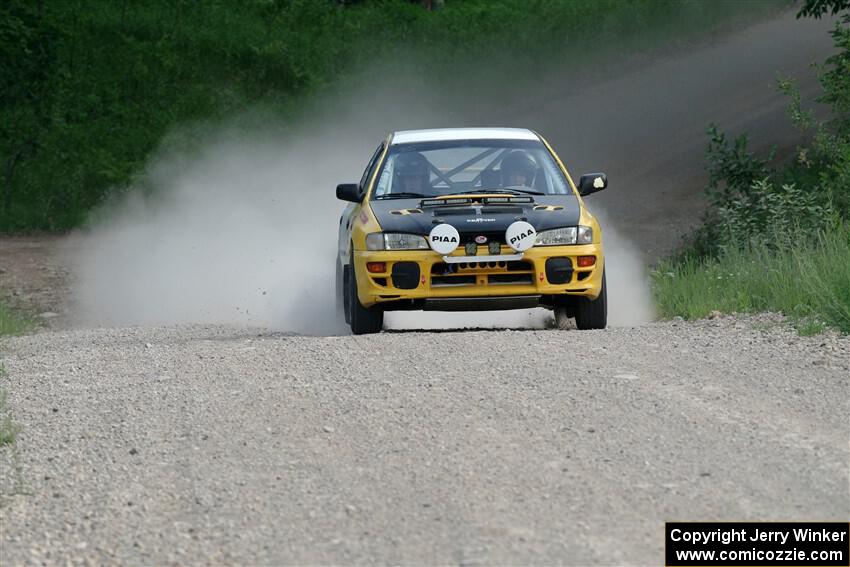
[{"xmin": 369, "ymin": 195, "xmax": 581, "ymax": 243}]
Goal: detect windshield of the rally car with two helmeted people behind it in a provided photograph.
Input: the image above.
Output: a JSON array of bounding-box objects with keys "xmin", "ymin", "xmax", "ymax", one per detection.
[{"xmin": 372, "ymin": 140, "xmax": 572, "ymax": 199}]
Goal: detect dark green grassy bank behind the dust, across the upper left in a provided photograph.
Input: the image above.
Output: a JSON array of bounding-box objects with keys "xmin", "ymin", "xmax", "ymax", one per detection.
[{"xmin": 0, "ymin": 0, "xmax": 784, "ymax": 232}]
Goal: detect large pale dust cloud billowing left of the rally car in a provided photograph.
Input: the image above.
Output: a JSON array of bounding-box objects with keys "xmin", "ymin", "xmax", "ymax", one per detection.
[{"xmin": 69, "ymin": 115, "xmax": 377, "ymax": 334}]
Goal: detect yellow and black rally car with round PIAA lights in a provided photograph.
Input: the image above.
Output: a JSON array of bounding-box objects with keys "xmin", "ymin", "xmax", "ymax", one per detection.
[{"xmin": 336, "ymin": 128, "xmax": 608, "ymax": 334}]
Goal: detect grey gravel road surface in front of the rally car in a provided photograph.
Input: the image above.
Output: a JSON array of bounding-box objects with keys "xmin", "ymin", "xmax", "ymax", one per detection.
[{"xmin": 0, "ymin": 316, "xmax": 850, "ymax": 565}]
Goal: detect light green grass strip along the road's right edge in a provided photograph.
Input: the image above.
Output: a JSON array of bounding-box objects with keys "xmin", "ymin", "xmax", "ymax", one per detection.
[{"xmin": 653, "ymin": 222, "xmax": 850, "ymax": 335}]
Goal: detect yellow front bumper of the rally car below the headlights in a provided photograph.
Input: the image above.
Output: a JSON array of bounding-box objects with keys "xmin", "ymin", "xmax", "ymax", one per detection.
[{"xmin": 354, "ymin": 244, "xmax": 604, "ymax": 310}]
